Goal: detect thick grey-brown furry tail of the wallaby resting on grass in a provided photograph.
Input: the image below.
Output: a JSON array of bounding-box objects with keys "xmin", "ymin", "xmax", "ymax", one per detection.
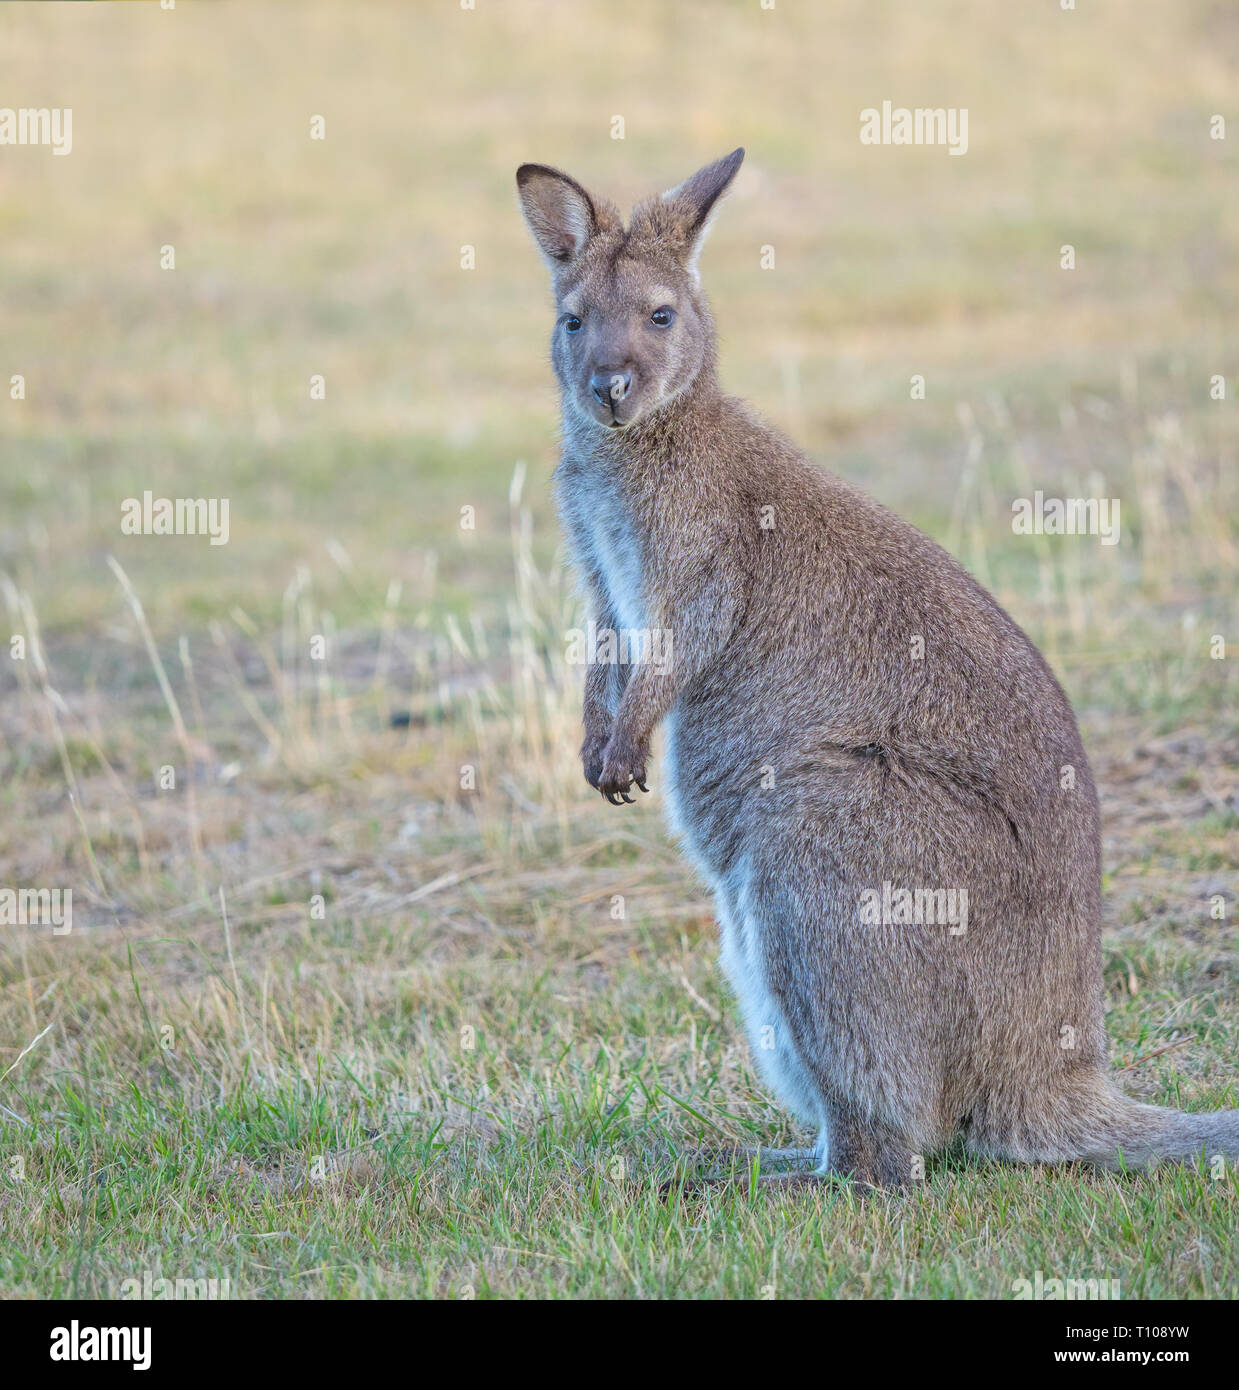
[{"xmin": 978, "ymin": 1073, "xmax": 1239, "ymax": 1169}]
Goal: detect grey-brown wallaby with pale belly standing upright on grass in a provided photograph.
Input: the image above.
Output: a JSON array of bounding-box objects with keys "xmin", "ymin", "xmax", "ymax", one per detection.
[{"xmin": 516, "ymin": 150, "xmax": 1239, "ymax": 1186}]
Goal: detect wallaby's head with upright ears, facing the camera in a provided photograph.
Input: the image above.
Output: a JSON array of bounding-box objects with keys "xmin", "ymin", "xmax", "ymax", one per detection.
[{"xmin": 516, "ymin": 150, "xmax": 744, "ymax": 430}]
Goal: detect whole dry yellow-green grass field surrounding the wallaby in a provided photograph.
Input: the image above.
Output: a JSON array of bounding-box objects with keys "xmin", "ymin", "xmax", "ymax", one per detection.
[{"xmin": 0, "ymin": 0, "xmax": 1239, "ymax": 1298}]
